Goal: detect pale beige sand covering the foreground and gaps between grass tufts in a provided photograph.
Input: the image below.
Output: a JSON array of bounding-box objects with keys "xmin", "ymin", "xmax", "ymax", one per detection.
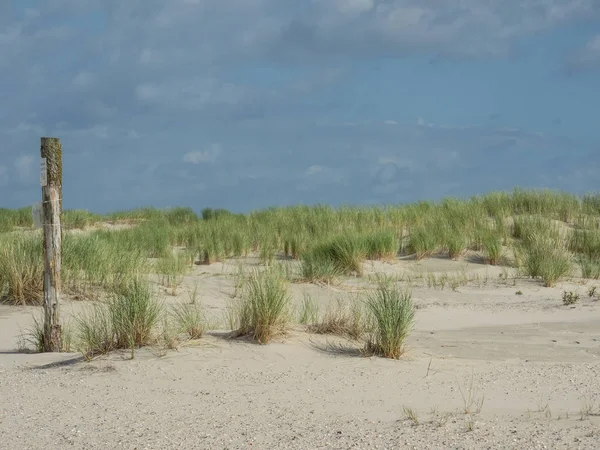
[{"xmin": 0, "ymin": 259, "xmax": 600, "ymax": 450}]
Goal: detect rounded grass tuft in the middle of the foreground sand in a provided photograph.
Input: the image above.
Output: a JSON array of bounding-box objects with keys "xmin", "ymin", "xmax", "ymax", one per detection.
[{"xmin": 229, "ymin": 269, "xmax": 291, "ymax": 344}]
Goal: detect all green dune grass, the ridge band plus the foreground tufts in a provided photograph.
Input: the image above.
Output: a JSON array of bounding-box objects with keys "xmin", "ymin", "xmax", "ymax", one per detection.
[{"xmin": 0, "ymin": 189, "xmax": 600, "ymax": 357}]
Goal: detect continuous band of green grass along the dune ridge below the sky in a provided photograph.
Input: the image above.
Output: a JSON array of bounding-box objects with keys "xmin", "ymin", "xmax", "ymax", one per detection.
[{"xmin": 0, "ymin": 189, "xmax": 600, "ymax": 312}]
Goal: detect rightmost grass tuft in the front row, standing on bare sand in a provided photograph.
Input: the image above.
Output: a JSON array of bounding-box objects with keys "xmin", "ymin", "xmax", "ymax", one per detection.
[{"xmin": 358, "ymin": 278, "xmax": 415, "ymax": 359}]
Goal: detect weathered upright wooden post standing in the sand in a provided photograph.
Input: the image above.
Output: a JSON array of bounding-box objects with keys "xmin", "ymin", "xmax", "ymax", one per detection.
[{"xmin": 40, "ymin": 137, "xmax": 62, "ymax": 352}]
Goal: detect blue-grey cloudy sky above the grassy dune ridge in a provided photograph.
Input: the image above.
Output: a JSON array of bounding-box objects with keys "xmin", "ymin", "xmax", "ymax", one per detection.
[{"xmin": 0, "ymin": 0, "xmax": 600, "ymax": 213}]
